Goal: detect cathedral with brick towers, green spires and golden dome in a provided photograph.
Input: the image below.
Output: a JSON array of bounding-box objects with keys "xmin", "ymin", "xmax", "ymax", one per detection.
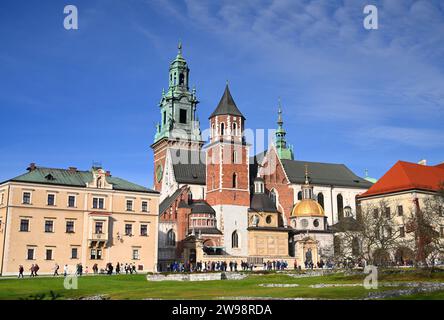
[{"xmin": 151, "ymin": 45, "xmax": 372, "ymax": 271}]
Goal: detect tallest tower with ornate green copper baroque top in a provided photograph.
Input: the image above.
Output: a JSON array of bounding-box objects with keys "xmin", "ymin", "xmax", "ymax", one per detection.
[{"xmin": 151, "ymin": 43, "xmax": 204, "ymax": 192}]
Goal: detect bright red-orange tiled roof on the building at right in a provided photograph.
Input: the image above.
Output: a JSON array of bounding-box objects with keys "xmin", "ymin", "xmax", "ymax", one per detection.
[{"xmin": 359, "ymin": 161, "xmax": 444, "ymax": 198}]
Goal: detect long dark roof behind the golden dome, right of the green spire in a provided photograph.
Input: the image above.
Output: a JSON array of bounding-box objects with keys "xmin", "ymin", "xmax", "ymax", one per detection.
[{"xmin": 281, "ymin": 159, "xmax": 373, "ymax": 188}]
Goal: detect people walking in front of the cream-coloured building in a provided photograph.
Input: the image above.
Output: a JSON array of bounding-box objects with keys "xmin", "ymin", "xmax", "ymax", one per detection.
[{"xmin": 18, "ymin": 262, "xmax": 137, "ymax": 278}]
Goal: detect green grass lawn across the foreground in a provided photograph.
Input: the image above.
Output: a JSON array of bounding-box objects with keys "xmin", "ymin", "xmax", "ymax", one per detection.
[{"xmin": 0, "ymin": 272, "xmax": 444, "ymax": 299}]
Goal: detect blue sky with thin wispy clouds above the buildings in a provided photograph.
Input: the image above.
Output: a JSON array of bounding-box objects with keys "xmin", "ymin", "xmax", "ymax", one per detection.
[{"xmin": 0, "ymin": 0, "xmax": 444, "ymax": 186}]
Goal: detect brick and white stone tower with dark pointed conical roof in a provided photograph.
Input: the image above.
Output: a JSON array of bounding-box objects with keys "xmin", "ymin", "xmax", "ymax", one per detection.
[{"xmin": 205, "ymin": 84, "xmax": 250, "ymax": 255}]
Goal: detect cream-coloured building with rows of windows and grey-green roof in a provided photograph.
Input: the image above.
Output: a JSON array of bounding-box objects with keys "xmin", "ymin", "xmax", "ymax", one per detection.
[{"xmin": 0, "ymin": 164, "xmax": 159, "ymax": 275}]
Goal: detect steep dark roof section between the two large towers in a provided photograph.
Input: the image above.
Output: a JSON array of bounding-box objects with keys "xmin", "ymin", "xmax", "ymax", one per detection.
[{"xmin": 172, "ymin": 149, "xmax": 206, "ymax": 185}]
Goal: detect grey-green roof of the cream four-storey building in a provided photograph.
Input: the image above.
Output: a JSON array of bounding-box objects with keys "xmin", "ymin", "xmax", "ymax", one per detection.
[{"xmin": 6, "ymin": 167, "xmax": 158, "ymax": 193}]
